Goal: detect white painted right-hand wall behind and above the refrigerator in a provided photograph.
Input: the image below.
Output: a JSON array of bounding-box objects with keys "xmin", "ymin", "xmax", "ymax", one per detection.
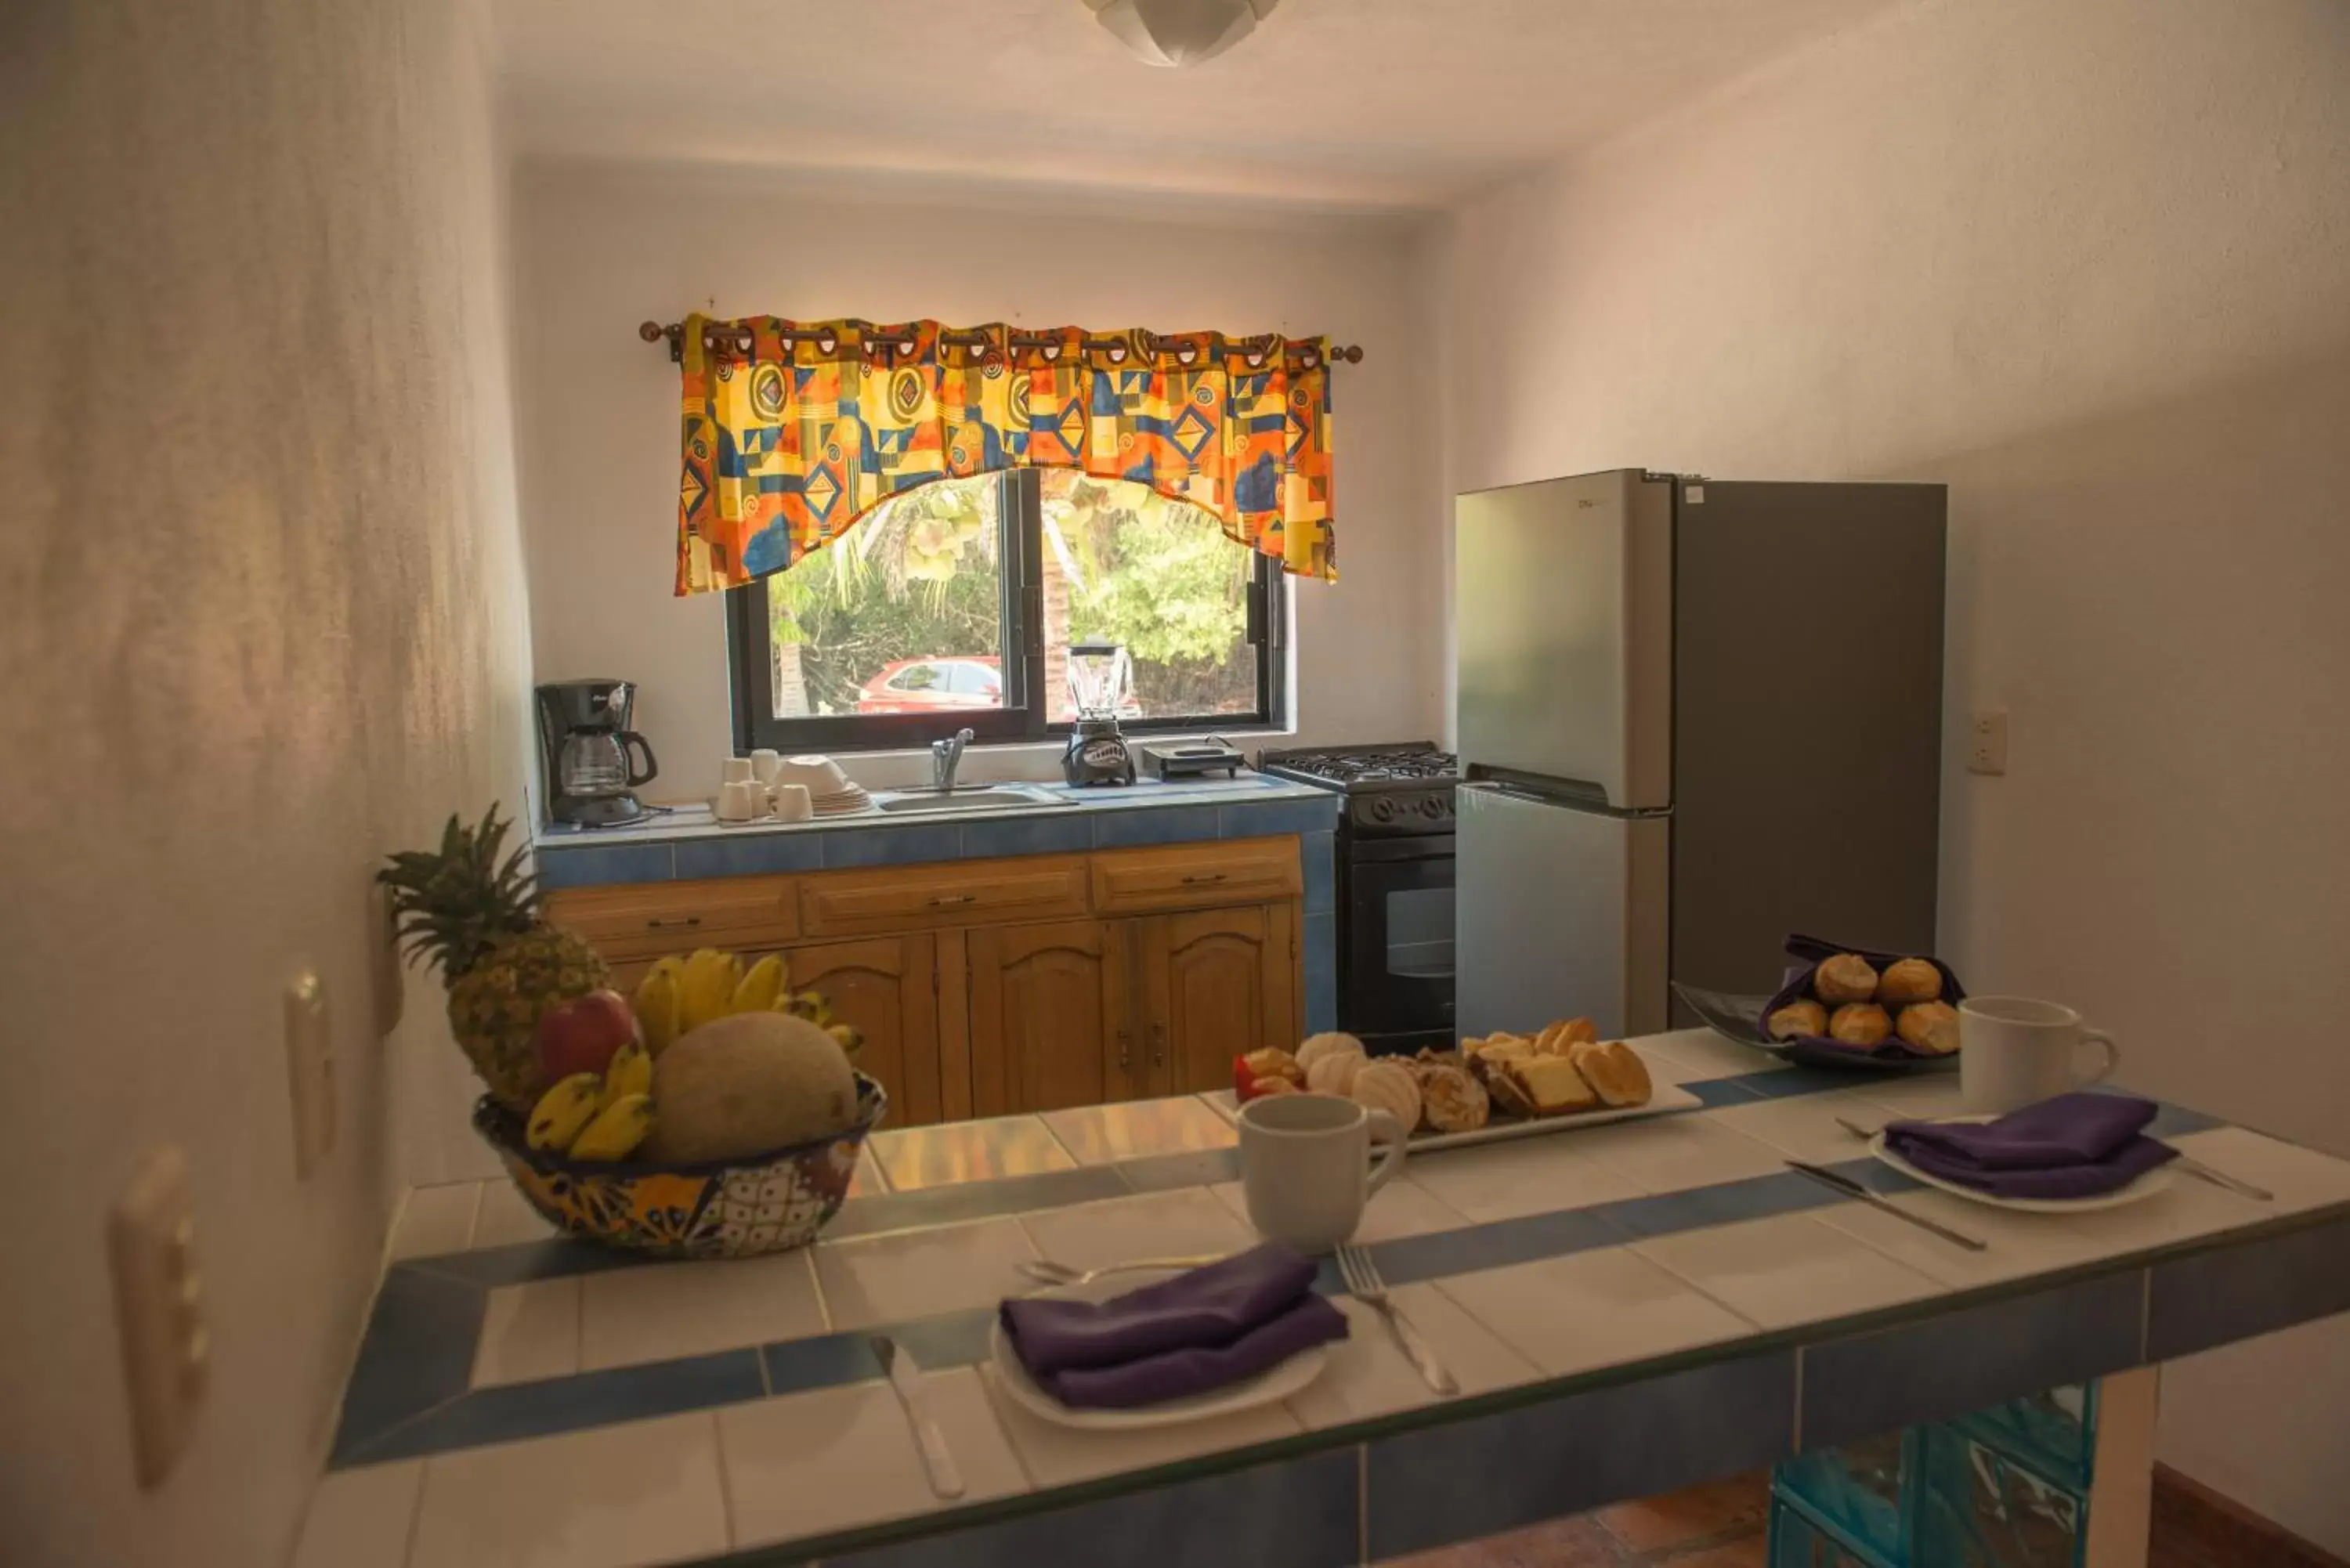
[{"xmin": 1424, "ymin": 0, "xmax": 2350, "ymax": 1552}]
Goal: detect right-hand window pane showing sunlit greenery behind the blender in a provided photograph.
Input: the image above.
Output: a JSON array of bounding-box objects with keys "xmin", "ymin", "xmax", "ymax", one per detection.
[{"xmin": 1041, "ymin": 468, "xmax": 1257, "ymax": 724}]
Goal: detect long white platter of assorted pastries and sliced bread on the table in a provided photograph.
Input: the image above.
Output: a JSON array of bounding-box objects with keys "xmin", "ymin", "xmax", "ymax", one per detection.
[{"xmin": 1234, "ymin": 1018, "xmax": 1699, "ymax": 1150}]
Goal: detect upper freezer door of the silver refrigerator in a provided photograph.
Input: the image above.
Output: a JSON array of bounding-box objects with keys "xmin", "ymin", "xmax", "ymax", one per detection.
[{"xmin": 1452, "ymin": 468, "xmax": 1673, "ymax": 811}]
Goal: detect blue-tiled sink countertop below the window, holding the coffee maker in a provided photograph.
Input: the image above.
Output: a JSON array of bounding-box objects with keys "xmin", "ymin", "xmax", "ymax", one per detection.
[{"xmin": 533, "ymin": 773, "xmax": 1340, "ymax": 889}]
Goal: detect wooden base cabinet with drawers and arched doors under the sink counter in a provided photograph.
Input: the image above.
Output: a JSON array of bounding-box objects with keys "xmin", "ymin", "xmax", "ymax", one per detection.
[{"xmin": 548, "ymin": 837, "xmax": 1304, "ymax": 1126}]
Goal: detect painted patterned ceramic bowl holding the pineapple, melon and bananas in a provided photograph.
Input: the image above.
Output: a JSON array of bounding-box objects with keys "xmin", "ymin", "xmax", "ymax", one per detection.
[{"xmin": 472, "ymin": 1072, "xmax": 888, "ymax": 1258}]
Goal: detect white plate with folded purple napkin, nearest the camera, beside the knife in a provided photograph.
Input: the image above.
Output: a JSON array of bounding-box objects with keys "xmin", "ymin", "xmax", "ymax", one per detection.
[{"xmin": 1003, "ymin": 1241, "xmax": 1347, "ymax": 1411}]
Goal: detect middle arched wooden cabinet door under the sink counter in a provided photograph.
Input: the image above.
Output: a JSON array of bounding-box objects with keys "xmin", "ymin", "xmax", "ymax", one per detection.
[{"xmin": 966, "ymin": 919, "xmax": 1133, "ymax": 1117}]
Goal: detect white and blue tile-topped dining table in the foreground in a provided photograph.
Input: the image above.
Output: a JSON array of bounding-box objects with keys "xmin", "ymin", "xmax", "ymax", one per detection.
[{"xmin": 296, "ymin": 1032, "xmax": 2350, "ymax": 1568}]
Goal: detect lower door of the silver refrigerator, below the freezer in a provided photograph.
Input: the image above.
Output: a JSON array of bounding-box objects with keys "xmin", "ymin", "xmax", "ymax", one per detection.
[{"xmin": 1452, "ymin": 782, "xmax": 1673, "ymax": 1039}]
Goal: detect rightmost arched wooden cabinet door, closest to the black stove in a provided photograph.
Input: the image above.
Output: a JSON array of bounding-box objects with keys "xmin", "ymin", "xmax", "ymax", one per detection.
[{"xmin": 1133, "ymin": 903, "xmax": 1297, "ymax": 1093}]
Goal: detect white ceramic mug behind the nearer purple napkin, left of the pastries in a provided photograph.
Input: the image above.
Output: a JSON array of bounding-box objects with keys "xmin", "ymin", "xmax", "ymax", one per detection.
[{"xmin": 1241, "ymin": 1093, "xmax": 1403, "ymax": 1253}]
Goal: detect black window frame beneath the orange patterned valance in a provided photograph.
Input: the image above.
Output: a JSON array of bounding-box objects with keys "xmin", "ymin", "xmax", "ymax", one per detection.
[{"xmin": 724, "ymin": 468, "xmax": 1290, "ymax": 752}]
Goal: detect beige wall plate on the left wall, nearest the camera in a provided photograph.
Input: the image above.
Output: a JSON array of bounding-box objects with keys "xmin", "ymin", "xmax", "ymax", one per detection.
[{"xmin": 106, "ymin": 1143, "xmax": 212, "ymax": 1490}]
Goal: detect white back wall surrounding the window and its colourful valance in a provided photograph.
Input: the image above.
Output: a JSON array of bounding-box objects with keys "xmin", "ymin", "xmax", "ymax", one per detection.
[{"xmin": 517, "ymin": 164, "xmax": 1445, "ymax": 800}]
